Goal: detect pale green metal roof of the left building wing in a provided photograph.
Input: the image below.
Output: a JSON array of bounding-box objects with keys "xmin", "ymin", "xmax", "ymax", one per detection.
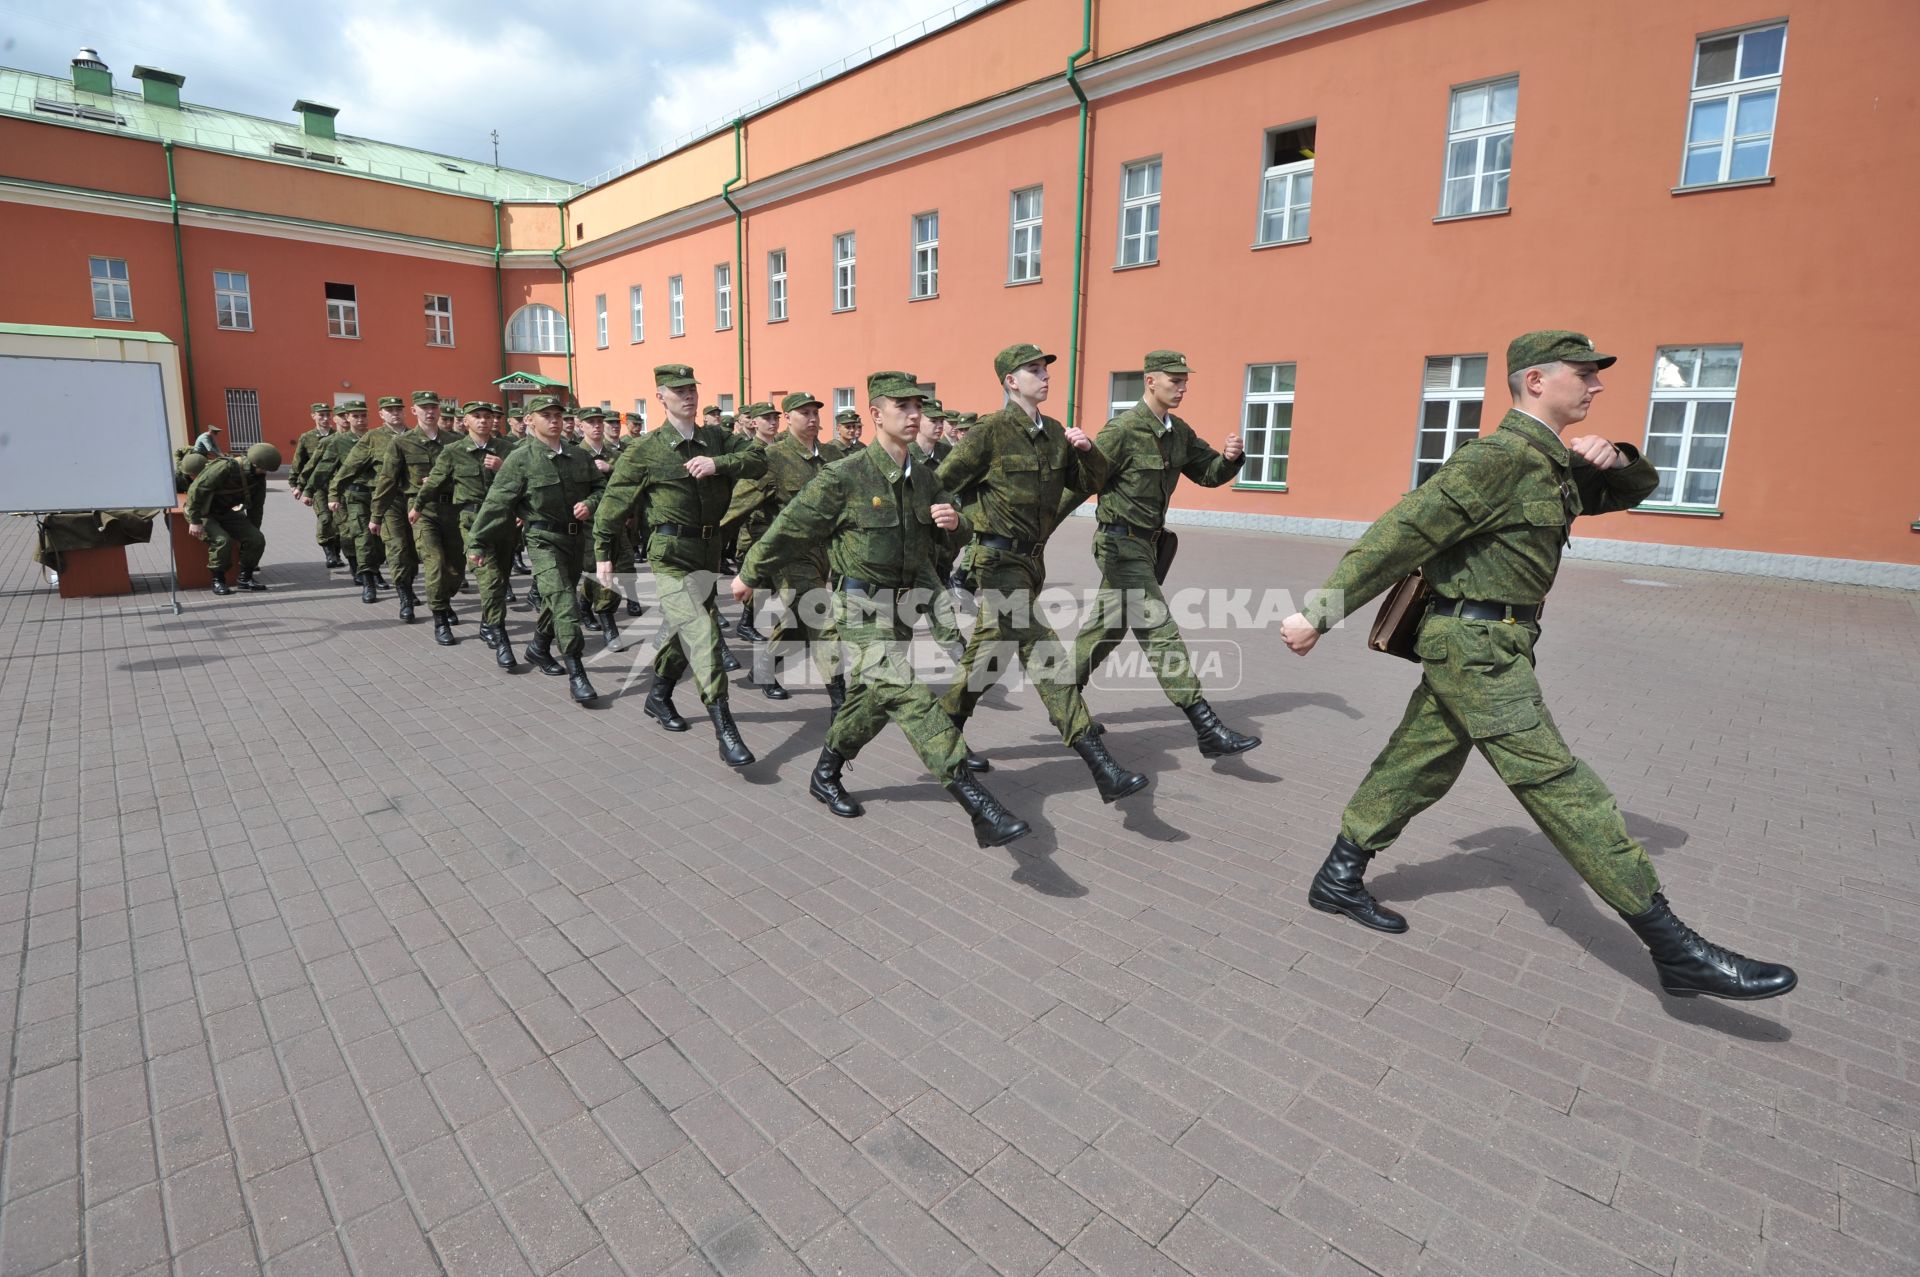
[{"xmin": 0, "ymin": 67, "xmax": 584, "ymax": 202}]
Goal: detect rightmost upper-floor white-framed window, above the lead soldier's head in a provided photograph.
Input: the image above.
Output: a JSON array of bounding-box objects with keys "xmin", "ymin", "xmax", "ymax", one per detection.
[{"xmin": 1680, "ymin": 23, "xmax": 1788, "ymax": 186}]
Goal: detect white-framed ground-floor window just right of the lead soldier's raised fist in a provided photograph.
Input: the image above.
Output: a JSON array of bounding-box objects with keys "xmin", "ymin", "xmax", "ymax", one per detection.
[{"xmin": 1642, "ymin": 346, "xmax": 1740, "ymax": 509}]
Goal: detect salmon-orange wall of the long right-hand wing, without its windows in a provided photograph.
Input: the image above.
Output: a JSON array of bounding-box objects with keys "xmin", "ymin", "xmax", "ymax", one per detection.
[{"xmin": 576, "ymin": 0, "xmax": 1920, "ymax": 563}]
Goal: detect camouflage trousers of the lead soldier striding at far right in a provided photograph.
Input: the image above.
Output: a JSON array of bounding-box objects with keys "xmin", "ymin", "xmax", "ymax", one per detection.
[{"xmin": 1340, "ymin": 616, "xmax": 1661, "ymax": 914}]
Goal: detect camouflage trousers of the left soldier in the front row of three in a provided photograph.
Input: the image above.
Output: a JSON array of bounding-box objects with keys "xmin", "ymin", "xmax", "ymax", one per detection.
[{"xmin": 828, "ymin": 591, "xmax": 966, "ymax": 785}]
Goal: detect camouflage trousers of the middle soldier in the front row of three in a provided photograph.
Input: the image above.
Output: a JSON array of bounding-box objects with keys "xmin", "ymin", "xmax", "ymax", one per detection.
[{"xmin": 941, "ymin": 545, "xmax": 1092, "ymax": 745}]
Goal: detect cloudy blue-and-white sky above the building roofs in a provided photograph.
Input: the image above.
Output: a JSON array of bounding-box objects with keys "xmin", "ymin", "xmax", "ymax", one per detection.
[{"xmin": 0, "ymin": 0, "xmax": 960, "ymax": 181}]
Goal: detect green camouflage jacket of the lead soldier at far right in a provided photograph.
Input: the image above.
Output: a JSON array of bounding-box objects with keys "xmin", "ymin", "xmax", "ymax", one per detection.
[{"xmin": 1306, "ymin": 411, "xmax": 1661, "ymax": 630}]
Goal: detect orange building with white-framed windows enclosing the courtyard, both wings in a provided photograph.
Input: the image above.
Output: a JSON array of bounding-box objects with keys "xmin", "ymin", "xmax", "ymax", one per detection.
[{"xmin": 0, "ymin": 0, "xmax": 1920, "ymax": 588}]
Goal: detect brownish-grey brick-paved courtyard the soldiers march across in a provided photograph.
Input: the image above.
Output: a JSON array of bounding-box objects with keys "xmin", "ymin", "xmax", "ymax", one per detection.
[{"xmin": 0, "ymin": 484, "xmax": 1920, "ymax": 1277}]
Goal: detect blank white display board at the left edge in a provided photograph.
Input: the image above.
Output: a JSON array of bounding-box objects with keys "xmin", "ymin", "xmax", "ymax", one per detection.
[{"xmin": 0, "ymin": 355, "xmax": 179, "ymax": 513}]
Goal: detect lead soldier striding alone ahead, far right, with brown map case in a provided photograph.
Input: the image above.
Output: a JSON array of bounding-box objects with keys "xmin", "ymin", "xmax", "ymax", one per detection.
[{"xmin": 1283, "ymin": 328, "xmax": 1797, "ymax": 999}]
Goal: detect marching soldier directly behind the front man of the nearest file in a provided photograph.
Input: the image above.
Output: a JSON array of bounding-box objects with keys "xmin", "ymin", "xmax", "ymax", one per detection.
[{"xmin": 593, "ymin": 363, "xmax": 766, "ymax": 766}]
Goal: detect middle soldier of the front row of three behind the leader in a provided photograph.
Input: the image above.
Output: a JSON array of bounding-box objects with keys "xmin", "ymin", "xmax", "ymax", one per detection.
[{"xmin": 941, "ymin": 342, "xmax": 1146, "ymax": 803}]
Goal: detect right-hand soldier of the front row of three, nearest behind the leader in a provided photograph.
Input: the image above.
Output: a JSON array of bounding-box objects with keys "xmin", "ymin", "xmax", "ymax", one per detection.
[{"xmin": 1056, "ymin": 349, "xmax": 1260, "ymax": 759}]
